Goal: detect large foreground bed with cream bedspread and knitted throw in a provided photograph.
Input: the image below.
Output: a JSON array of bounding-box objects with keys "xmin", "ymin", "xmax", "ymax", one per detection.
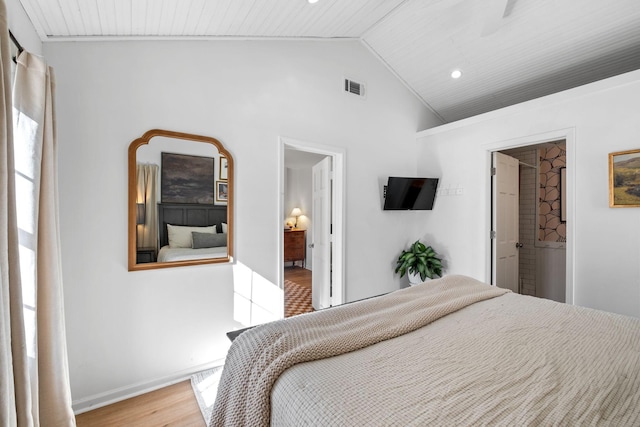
[{"xmin": 211, "ymin": 276, "xmax": 640, "ymax": 426}]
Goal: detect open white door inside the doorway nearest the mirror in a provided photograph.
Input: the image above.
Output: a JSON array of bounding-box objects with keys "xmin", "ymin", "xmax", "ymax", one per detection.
[{"xmin": 311, "ymin": 156, "xmax": 331, "ymax": 310}]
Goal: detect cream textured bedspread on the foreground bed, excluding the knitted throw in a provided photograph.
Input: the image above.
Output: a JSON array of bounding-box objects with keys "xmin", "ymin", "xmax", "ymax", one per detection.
[{"xmin": 271, "ymin": 294, "xmax": 640, "ymax": 427}]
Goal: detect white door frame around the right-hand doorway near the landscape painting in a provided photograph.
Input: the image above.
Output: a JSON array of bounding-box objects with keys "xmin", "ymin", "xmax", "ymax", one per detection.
[{"xmin": 483, "ymin": 127, "xmax": 576, "ymax": 304}]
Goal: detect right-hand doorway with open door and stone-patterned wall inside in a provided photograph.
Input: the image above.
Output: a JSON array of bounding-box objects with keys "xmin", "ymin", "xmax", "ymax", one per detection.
[{"xmin": 490, "ymin": 130, "xmax": 573, "ymax": 304}]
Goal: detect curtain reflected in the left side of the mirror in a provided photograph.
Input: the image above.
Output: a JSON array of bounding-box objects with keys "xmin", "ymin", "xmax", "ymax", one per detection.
[{"xmin": 136, "ymin": 163, "xmax": 159, "ymax": 253}]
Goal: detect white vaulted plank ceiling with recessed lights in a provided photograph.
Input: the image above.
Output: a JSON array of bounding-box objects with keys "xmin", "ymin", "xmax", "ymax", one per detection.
[{"xmin": 16, "ymin": 0, "xmax": 640, "ymax": 122}]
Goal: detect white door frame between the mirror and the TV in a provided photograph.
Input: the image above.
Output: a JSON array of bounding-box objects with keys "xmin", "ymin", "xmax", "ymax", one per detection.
[{"xmin": 275, "ymin": 136, "xmax": 346, "ymax": 306}]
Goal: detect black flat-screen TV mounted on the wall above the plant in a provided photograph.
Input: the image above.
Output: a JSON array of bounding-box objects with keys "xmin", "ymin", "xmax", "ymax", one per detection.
[{"xmin": 384, "ymin": 176, "xmax": 438, "ymax": 211}]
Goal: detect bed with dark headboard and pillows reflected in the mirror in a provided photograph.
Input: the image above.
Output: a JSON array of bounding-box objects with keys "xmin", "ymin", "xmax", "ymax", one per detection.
[{"xmin": 157, "ymin": 203, "xmax": 228, "ymax": 262}]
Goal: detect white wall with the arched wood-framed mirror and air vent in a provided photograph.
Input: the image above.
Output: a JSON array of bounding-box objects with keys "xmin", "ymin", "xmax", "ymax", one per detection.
[{"xmin": 44, "ymin": 41, "xmax": 437, "ymax": 408}]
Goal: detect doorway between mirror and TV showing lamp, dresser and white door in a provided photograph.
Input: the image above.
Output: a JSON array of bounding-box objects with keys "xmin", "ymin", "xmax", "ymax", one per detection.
[{"xmin": 279, "ymin": 138, "xmax": 344, "ymax": 316}]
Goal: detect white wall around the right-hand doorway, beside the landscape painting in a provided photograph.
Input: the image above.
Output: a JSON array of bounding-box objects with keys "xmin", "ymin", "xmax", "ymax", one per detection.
[{"xmin": 418, "ymin": 71, "xmax": 640, "ymax": 316}]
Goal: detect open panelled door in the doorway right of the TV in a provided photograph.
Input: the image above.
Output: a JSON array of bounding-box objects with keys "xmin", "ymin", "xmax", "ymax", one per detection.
[{"xmin": 491, "ymin": 152, "xmax": 520, "ymax": 292}]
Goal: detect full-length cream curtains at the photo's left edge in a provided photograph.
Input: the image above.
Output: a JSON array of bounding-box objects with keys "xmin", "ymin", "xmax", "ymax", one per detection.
[{"xmin": 0, "ymin": 4, "xmax": 75, "ymax": 426}]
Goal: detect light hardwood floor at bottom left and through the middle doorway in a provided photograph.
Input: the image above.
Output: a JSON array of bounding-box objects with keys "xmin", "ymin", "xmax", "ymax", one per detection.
[{"xmin": 76, "ymin": 267, "xmax": 311, "ymax": 427}]
